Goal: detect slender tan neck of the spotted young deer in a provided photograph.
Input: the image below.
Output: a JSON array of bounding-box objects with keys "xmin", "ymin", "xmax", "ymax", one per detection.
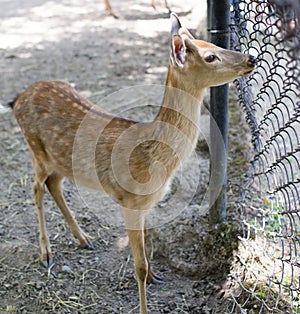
[{"xmin": 141, "ymin": 63, "xmax": 205, "ymax": 182}]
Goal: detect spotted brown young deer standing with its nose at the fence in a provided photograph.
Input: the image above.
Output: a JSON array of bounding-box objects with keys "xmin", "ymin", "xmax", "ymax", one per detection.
[{"xmin": 11, "ymin": 13, "xmax": 256, "ymax": 314}]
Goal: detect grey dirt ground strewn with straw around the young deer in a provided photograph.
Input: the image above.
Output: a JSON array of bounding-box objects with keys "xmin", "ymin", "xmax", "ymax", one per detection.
[{"xmin": 0, "ymin": 0, "xmax": 245, "ymax": 314}]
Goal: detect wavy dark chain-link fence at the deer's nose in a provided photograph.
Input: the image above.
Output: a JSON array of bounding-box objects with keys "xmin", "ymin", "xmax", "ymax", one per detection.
[{"xmin": 228, "ymin": 0, "xmax": 300, "ymax": 314}]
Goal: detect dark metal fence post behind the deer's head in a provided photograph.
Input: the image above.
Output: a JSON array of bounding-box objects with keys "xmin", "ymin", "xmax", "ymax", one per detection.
[{"xmin": 207, "ymin": 0, "xmax": 230, "ymax": 224}]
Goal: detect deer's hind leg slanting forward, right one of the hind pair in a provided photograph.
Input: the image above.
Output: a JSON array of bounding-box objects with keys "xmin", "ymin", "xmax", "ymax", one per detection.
[{"xmin": 46, "ymin": 172, "xmax": 94, "ymax": 250}]
